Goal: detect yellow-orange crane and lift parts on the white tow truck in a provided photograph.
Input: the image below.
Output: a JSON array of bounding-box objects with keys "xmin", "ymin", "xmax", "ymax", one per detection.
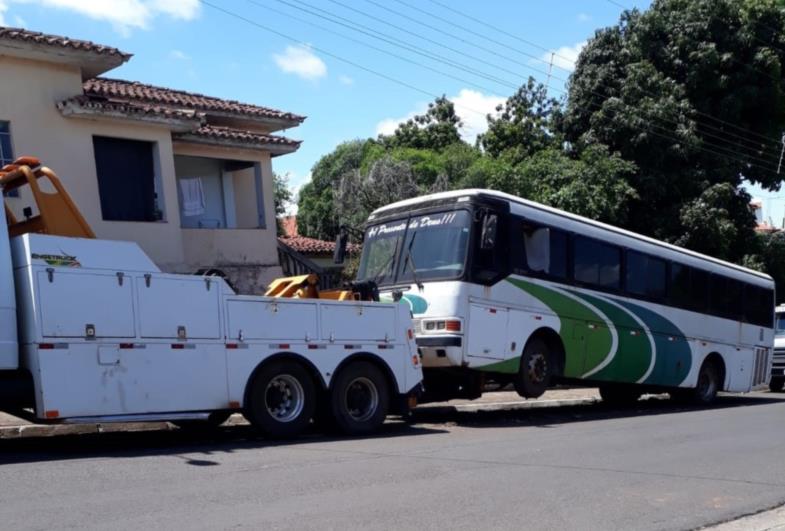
[{"xmin": 0, "ymin": 156, "xmax": 374, "ymax": 301}]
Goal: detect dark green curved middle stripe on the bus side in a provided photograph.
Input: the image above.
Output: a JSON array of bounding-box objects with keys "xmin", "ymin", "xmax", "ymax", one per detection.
[{"xmin": 569, "ymin": 290, "xmax": 654, "ymax": 383}]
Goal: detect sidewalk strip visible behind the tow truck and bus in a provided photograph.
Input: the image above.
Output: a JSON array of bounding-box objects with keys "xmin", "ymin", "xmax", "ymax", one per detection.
[{"xmin": 0, "ymin": 389, "xmax": 600, "ymax": 439}]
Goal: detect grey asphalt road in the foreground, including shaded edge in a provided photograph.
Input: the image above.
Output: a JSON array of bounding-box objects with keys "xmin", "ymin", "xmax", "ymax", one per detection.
[{"xmin": 0, "ymin": 393, "xmax": 785, "ymax": 530}]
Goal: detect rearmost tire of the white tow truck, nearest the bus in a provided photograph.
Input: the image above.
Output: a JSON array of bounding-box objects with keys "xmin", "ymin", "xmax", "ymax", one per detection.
[{"xmin": 330, "ymin": 361, "xmax": 390, "ymax": 435}]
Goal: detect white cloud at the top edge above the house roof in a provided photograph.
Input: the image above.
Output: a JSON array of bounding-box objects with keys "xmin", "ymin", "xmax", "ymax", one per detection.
[{"xmin": 0, "ymin": 0, "xmax": 200, "ymax": 35}]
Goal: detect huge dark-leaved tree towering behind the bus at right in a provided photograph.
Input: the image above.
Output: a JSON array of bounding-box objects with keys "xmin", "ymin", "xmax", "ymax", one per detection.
[{"xmin": 560, "ymin": 0, "xmax": 785, "ymax": 260}]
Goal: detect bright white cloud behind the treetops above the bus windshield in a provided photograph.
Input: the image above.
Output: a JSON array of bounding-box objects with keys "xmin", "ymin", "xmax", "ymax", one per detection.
[{"xmin": 376, "ymin": 89, "xmax": 506, "ymax": 144}]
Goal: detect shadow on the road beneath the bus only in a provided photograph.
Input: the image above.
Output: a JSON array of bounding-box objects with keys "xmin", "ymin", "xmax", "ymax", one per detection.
[{"xmin": 413, "ymin": 394, "xmax": 785, "ymax": 428}]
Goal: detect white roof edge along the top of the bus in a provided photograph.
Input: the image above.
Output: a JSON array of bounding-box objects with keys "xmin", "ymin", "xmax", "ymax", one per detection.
[{"xmin": 370, "ymin": 188, "xmax": 773, "ymax": 280}]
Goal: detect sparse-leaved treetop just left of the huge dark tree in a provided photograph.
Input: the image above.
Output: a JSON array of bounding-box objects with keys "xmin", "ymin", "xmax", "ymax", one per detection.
[{"xmin": 477, "ymin": 77, "xmax": 559, "ymax": 162}]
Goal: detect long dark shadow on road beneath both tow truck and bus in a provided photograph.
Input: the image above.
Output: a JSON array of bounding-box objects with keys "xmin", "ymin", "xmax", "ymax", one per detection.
[{"xmin": 0, "ymin": 395, "xmax": 785, "ymax": 467}]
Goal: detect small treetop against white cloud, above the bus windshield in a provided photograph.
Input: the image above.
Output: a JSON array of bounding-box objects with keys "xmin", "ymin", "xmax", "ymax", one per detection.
[{"xmin": 380, "ymin": 96, "xmax": 463, "ymax": 150}]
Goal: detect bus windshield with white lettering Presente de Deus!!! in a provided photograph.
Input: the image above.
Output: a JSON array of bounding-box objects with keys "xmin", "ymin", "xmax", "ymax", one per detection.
[{"xmin": 357, "ymin": 210, "xmax": 471, "ymax": 285}]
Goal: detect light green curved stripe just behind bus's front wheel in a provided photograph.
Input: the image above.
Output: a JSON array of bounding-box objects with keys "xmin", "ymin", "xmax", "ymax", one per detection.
[{"xmin": 507, "ymin": 278, "xmax": 613, "ymax": 378}]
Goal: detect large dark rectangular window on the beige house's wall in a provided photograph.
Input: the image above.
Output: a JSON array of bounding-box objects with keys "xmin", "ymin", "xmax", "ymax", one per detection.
[{"xmin": 93, "ymin": 136, "xmax": 163, "ymax": 221}]
